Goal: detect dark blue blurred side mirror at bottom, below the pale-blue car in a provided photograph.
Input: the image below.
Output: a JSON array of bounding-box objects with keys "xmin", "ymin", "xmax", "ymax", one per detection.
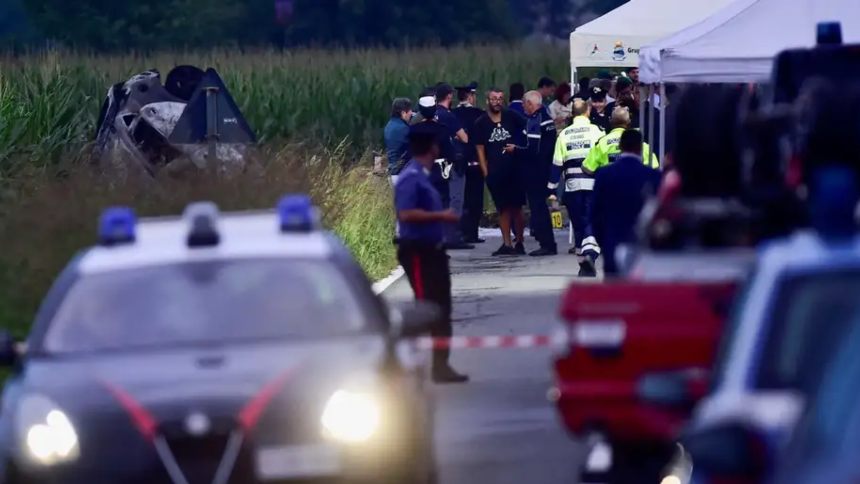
[{"xmin": 681, "ymin": 422, "xmax": 768, "ymax": 482}]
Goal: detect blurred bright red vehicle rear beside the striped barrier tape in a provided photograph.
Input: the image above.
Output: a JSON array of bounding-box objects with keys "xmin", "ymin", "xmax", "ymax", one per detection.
[{"xmin": 552, "ymin": 264, "xmax": 736, "ymax": 482}]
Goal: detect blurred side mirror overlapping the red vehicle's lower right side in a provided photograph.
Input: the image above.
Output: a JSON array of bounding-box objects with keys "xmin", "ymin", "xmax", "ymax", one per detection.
[{"xmin": 637, "ymin": 370, "xmax": 708, "ymax": 408}]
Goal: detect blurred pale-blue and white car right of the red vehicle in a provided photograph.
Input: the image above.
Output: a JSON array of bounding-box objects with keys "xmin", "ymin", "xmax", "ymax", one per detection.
[{"xmin": 663, "ymin": 232, "xmax": 860, "ymax": 483}]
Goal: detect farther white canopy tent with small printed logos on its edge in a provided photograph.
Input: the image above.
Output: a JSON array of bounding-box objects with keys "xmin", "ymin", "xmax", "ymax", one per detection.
[{"xmin": 570, "ymin": 0, "xmax": 736, "ymax": 82}]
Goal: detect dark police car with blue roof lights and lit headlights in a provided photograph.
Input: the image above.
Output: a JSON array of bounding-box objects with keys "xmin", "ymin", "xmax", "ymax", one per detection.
[{"xmin": 0, "ymin": 196, "xmax": 439, "ymax": 484}]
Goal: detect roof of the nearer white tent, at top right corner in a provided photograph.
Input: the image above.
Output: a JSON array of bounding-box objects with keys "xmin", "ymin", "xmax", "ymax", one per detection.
[{"xmin": 640, "ymin": 0, "xmax": 860, "ymax": 83}]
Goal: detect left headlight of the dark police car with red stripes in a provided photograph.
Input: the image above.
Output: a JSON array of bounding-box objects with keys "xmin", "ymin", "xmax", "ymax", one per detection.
[{"xmin": 16, "ymin": 395, "xmax": 79, "ymax": 466}]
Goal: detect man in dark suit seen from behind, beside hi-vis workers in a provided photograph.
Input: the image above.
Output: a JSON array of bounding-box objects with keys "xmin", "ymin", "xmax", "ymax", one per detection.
[{"xmin": 592, "ymin": 129, "xmax": 661, "ymax": 275}]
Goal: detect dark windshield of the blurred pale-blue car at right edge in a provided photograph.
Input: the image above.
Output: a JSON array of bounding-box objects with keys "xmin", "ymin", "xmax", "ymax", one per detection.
[{"xmin": 755, "ymin": 271, "xmax": 860, "ymax": 392}]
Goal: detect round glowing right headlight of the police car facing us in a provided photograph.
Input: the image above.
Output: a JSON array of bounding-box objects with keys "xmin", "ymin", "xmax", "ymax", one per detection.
[{"xmin": 321, "ymin": 390, "xmax": 382, "ymax": 443}]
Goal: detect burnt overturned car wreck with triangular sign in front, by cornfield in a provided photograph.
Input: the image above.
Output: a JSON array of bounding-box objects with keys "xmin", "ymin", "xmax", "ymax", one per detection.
[{"xmin": 95, "ymin": 66, "xmax": 256, "ymax": 177}]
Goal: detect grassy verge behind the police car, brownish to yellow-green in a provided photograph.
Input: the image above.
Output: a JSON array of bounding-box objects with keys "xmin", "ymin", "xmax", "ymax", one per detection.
[{"xmin": 0, "ymin": 145, "xmax": 396, "ymax": 336}]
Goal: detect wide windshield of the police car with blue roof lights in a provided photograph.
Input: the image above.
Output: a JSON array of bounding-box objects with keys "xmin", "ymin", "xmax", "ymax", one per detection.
[{"xmin": 43, "ymin": 260, "xmax": 371, "ymax": 353}]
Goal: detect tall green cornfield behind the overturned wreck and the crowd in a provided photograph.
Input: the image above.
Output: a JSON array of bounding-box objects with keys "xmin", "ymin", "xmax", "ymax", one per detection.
[{"xmin": 0, "ymin": 46, "xmax": 568, "ymax": 176}]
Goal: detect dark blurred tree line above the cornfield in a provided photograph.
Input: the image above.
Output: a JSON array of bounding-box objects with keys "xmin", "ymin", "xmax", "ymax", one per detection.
[{"xmin": 0, "ymin": 0, "xmax": 625, "ymax": 51}]
